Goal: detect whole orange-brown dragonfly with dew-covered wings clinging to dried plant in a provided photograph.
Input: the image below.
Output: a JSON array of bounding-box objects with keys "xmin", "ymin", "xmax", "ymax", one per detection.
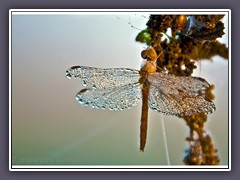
[{"xmin": 66, "ymin": 47, "xmax": 216, "ymax": 152}]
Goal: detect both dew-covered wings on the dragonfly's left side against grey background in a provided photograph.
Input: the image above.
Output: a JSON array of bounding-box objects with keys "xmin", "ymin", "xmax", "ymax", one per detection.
[{"xmin": 67, "ymin": 66, "xmax": 141, "ymax": 111}]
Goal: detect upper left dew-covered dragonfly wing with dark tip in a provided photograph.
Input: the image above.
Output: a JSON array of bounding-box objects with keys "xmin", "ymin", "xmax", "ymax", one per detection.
[{"xmin": 66, "ymin": 66, "xmax": 139, "ymax": 89}]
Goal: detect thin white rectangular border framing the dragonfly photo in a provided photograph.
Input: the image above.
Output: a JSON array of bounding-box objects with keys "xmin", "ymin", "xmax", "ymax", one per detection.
[{"xmin": 9, "ymin": 9, "xmax": 231, "ymax": 171}]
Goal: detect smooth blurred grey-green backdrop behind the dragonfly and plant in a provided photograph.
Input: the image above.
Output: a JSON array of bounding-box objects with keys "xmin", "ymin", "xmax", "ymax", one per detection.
[{"xmin": 12, "ymin": 13, "xmax": 229, "ymax": 165}]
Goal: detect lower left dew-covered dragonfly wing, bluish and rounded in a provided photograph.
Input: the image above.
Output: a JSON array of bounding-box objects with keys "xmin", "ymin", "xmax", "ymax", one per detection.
[{"xmin": 76, "ymin": 82, "xmax": 141, "ymax": 111}]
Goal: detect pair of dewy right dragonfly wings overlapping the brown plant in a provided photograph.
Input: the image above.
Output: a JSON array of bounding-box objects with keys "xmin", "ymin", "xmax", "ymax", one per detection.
[{"xmin": 148, "ymin": 73, "xmax": 216, "ymax": 116}]
